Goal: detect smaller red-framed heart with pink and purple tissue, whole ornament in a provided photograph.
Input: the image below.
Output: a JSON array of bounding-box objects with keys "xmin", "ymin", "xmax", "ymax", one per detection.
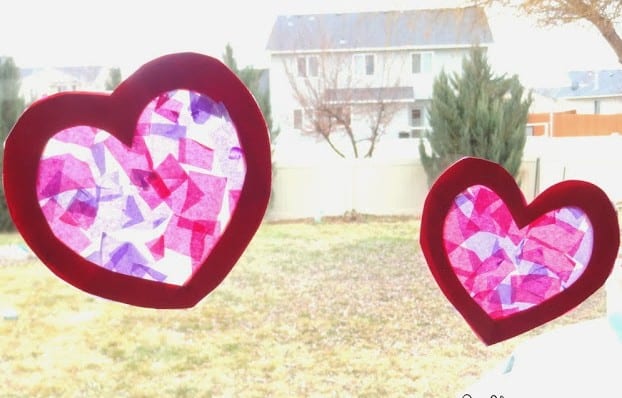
[{"xmin": 420, "ymin": 158, "xmax": 619, "ymax": 344}]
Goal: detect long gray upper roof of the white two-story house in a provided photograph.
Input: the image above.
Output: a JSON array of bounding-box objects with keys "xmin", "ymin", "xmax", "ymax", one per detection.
[{"xmin": 267, "ymin": 7, "xmax": 492, "ymax": 52}]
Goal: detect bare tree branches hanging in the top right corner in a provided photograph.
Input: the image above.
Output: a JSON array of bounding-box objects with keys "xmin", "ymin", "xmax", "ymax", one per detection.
[{"xmin": 467, "ymin": 0, "xmax": 622, "ymax": 64}]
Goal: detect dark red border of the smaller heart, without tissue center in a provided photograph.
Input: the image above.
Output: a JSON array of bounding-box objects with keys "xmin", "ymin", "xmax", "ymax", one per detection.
[{"xmin": 420, "ymin": 157, "xmax": 620, "ymax": 345}]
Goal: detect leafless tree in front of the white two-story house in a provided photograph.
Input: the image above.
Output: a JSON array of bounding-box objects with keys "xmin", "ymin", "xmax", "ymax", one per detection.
[{"xmin": 283, "ymin": 15, "xmax": 413, "ymax": 158}]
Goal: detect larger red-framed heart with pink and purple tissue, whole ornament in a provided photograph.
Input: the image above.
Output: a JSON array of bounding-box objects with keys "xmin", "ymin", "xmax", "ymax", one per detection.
[{"xmin": 3, "ymin": 53, "xmax": 271, "ymax": 308}]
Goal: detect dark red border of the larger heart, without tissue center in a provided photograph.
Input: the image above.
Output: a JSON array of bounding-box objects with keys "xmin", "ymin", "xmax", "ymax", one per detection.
[{"xmin": 3, "ymin": 53, "xmax": 271, "ymax": 308}]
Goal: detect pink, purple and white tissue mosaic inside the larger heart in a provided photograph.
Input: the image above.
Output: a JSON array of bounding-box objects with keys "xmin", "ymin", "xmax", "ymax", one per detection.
[{"xmin": 37, "ymin": 90, "xmax": 246, "ymax": 285}]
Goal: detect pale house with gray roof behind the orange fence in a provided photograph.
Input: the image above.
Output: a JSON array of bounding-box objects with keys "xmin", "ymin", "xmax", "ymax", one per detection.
[{"xmin": 534, "ymin": 70, "xmax": 622, "ymax": 115}]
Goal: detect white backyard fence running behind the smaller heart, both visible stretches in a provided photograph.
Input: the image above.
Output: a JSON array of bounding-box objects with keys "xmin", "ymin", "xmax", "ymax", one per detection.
[{"xmin": 266, "ymin": 136, "xmax": 622, "ymax": 220}]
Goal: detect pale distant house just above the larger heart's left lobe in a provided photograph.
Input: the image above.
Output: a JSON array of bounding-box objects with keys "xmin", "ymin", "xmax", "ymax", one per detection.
[{"xmin": 20, "ymin": 66, "xmax": 110, "ymax": 103}]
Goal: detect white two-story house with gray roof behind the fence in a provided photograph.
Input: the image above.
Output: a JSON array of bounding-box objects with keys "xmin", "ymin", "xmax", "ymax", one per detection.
[{"xmin": 267, "ymin": 7, "xmax": 492, "ymax": 157}]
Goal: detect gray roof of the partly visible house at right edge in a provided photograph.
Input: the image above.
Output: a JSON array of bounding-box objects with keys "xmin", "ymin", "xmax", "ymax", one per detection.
[{"xmin": 534, "ymin": 69, "xmax": 622, "ymax": 98}]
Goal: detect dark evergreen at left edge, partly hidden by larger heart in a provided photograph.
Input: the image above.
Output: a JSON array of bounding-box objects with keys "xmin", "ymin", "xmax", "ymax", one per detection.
[{"xmin": 0, "ymin": 57, "xmax": 24, "ymax": 231}]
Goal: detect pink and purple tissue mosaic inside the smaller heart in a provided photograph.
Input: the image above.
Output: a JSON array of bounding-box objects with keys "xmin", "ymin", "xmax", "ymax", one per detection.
[{"xmin": 443, "ymin": 185, "xmax": 594, "ymax": 318}]
